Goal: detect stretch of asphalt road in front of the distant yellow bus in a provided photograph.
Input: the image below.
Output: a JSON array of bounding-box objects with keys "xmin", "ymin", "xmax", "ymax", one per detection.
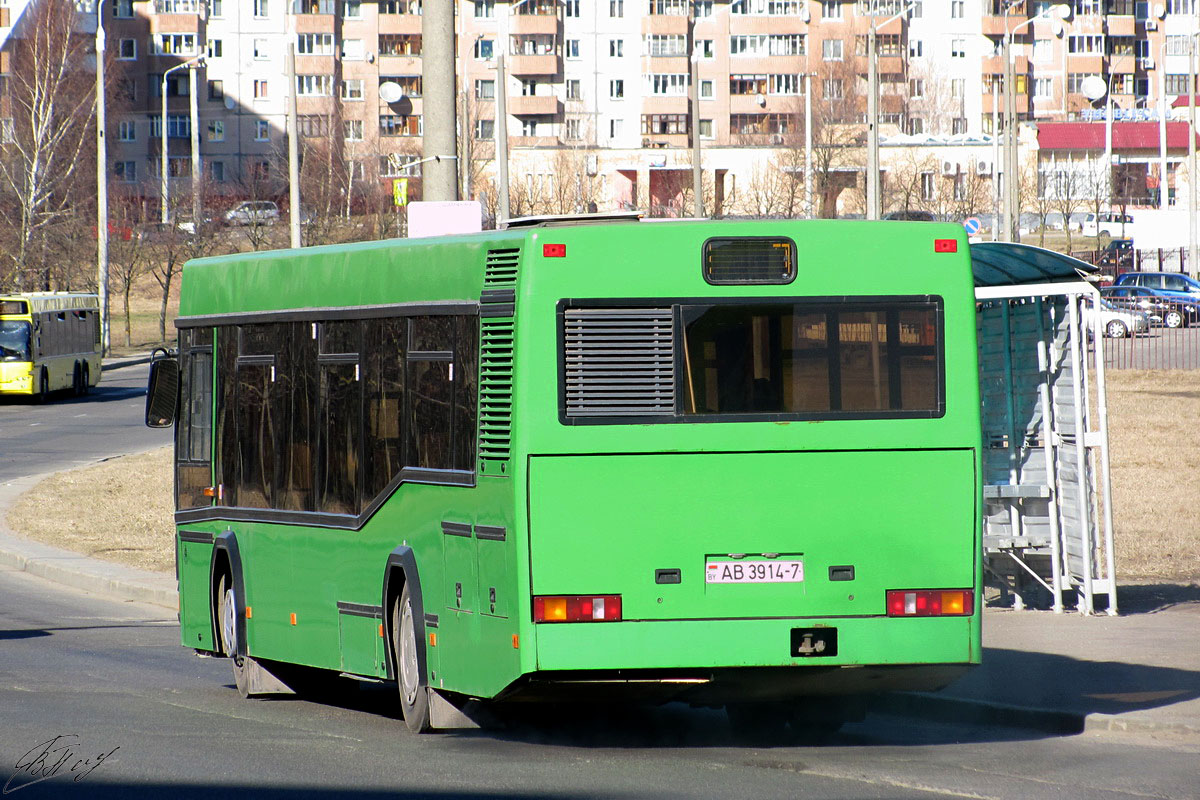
[{"xmin": 0, "ymin": 363, "xmax": 170, "ymax": 482}]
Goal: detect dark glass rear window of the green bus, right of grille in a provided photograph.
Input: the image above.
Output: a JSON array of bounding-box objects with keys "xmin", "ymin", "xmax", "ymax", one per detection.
[{"xmin": 680, "ymin": 302, "xmax": 943, "ymax": 417}]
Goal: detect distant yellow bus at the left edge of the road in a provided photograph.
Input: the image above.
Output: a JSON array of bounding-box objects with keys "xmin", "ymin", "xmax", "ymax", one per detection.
[{"xmin": 0, "ymin": 291, "xmax": 101, "ymax": 399}]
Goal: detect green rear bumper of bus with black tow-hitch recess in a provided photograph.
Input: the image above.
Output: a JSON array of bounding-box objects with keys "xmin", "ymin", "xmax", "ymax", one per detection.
[{"xmin": 514, "ymin": 615, "xmax": 980, "ymax": 702}]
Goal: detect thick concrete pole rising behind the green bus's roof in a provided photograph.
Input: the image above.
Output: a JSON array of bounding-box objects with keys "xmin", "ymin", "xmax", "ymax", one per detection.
[{"xmin": 421, "ymin": 0, "xmax": 458, "ymax": 200}]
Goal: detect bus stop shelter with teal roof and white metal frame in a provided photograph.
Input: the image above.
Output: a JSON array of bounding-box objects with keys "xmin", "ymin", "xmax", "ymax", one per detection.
[{"xmin": 971, "ymin": 242, "xmax": 1117, "ymax": 614}]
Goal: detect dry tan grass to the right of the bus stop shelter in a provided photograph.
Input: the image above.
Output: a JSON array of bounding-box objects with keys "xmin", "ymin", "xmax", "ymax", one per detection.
[{"xmin": 1106, "ymin": 369, "xmax": 1200, "ymax": 581}]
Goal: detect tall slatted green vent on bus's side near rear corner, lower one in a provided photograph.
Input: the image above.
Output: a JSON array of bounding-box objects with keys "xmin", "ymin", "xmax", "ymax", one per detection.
[{"xmin": 479, "ymin": 318, "xmax": 512, "ymax": 475}]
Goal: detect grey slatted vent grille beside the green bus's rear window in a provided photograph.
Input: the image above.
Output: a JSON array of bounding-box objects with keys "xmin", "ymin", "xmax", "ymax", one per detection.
[{"xmin": 564, "ymin": 308, "xmax": 674, "ymax": 416}]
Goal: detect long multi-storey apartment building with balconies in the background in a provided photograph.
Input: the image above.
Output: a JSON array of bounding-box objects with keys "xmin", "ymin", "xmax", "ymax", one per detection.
[{"xmin": 0, "ymin": 0, "xmax": 1198, "ymax": 212}]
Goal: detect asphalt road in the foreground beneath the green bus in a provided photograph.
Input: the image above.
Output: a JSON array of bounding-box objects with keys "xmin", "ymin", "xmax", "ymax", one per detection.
[{"xmin": 0, "ymin": 570, "xmax": 1200, "ymax": 800}]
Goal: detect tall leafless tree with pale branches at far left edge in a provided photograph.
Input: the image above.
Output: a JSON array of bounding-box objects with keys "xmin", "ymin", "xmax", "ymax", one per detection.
[{"xmin": 0, "ymin": 0, "xmax": 95, "ymax": 289}]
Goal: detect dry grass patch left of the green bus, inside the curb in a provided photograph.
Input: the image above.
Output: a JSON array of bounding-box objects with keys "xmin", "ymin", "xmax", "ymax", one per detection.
[{"xmin": 8, "ymin": 447, "xmax": 175, "ymax": 572}]
